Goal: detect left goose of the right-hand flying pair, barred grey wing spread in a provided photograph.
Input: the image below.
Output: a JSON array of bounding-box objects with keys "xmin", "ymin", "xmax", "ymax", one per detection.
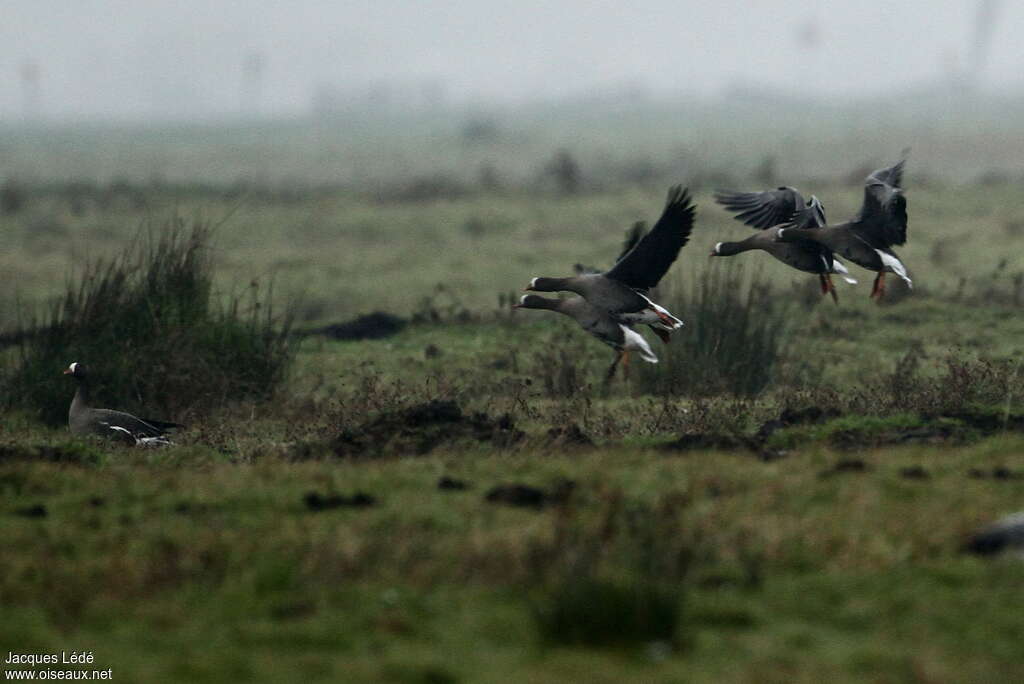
[{"xmin": 711, "ymin": 187, "xmax": 857, "ymax": 304}]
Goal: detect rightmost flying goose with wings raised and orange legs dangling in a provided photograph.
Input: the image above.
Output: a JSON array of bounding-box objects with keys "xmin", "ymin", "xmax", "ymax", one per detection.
[{"xmin": 776, "ymin": 157, "xmax": 913, "ymax": 301}]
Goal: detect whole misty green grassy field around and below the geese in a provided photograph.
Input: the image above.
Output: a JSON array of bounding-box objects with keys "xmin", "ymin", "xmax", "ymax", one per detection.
[{"xmin": 0, "ymin": 112, "xmax": 1024, "ymax": 682}]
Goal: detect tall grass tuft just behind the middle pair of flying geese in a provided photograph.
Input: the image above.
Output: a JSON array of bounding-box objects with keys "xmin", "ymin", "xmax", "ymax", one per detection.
[{"xmin": 637, "ymin": 259, "xmax": 803, "ymax": 396}]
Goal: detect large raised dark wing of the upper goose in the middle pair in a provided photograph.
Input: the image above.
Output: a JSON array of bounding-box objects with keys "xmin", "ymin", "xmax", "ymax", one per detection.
[{"xmin": 605, "ymin": 185, "xmax": 694, "ymax": 290}]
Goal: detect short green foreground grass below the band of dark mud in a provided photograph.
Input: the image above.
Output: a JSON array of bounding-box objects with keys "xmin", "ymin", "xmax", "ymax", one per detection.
[{"xmin": 0, "ymin": 432, "xmax": 1024, "ymax": 682}]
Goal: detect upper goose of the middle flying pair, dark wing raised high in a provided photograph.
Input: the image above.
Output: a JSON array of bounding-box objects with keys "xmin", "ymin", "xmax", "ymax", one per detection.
[{"xmin": 526, "ymin": 185, "xmax": 694, "ymax": 342}]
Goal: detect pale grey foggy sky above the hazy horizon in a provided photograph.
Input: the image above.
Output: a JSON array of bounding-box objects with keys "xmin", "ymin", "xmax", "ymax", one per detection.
[{"xmin": 0, "ymin": 0, "xmax": 1024, "ymax": 121}]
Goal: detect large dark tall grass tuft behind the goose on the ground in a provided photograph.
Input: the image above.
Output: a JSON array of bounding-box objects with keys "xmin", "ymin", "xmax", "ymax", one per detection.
[{"xmin": 2, "ymin": 218, "xmax": 293, "ymax": 424}]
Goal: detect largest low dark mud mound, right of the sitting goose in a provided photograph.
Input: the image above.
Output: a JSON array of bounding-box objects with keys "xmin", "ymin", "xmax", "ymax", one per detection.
[{"xmin": 292, "ymin": 400, "xmax": 523, "ymax": 460}]
